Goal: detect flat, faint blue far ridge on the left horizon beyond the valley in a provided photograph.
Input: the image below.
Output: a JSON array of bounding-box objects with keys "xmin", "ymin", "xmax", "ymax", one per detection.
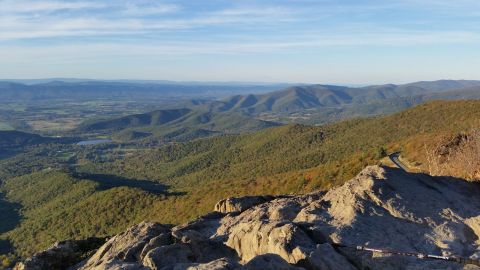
[{"xmin": 0, "ymin": 81, "xmax": 286, "ymax": 101}]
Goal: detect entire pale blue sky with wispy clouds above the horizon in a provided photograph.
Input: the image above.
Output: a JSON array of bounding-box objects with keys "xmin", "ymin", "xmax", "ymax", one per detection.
[{"xmin": 0, "ymin": 0, "xmax": 480, "ymax": 84}]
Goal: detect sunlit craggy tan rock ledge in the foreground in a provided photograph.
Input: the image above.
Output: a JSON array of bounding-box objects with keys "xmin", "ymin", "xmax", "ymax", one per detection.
[{"xmin": 16, "ymin": 166, "xmax": 480, "ymax": 270}]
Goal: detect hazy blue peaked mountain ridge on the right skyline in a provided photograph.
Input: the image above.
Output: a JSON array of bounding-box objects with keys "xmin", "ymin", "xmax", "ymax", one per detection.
[{"xmin": 212, "ymin": 80, "xmax": 480, "ymax": 114}]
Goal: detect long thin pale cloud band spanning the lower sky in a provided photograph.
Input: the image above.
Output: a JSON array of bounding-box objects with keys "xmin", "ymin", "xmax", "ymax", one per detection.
[{"xmin": 0, "ymin": 30, "xmax": 480, "ymax": 61}]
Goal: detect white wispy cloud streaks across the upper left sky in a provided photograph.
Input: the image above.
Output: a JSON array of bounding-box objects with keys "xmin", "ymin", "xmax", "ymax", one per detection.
[{"xmin": 0, "ymin": 0, "xmax": 300, "ymax": 41}]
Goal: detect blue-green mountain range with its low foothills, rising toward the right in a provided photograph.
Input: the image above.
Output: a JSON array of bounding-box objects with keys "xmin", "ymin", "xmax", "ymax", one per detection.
[{"xmin": 76, "ymin": 80, "xmax": 480, "ymax": 141}]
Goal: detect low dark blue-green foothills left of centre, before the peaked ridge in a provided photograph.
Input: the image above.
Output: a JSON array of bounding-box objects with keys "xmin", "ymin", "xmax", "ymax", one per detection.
[{"xmin": 76, "ymin": 109, "xmax": 278, "ymax": 141}]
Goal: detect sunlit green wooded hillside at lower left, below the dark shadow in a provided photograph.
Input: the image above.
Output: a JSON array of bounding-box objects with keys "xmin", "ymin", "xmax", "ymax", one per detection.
[{"xmin": 0, "ymin": 170, "xmax": 164, "ymax": 254}]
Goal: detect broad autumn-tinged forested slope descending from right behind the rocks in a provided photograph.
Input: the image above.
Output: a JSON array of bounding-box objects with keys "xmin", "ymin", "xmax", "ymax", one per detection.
[{"xmin": 79, "ymin": 101, "xmax": 480, "ymax": 223}]
